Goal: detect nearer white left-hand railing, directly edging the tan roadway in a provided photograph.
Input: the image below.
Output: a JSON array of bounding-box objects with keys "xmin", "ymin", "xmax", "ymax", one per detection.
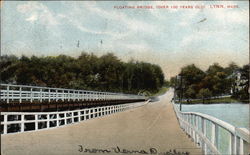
[{"xmin": 1, "ymin": 101, "xmax": 148, "ymax": 134}]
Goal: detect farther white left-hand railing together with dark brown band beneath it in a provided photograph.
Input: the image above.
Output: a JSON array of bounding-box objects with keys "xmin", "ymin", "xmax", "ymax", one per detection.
[{"xmin": 0, "ymin": 84, "xmax": 147, "ymax": 112}]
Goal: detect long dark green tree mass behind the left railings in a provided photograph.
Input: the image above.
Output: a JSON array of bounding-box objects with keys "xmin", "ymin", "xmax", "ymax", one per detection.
[{"xmin": 0, "ymin": 52, "xmax": 164, "ymax": 94}]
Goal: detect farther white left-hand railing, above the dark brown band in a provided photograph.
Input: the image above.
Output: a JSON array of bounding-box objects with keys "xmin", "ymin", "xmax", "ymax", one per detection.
[{"xmin": 0, "ymin": 84, "xmax": 146, "ymax": 103}]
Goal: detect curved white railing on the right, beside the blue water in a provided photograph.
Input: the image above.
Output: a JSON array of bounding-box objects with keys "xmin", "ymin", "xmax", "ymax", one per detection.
[{"xmin": 174, "ymin": 104, "xmax": 250, "ymax": 155}]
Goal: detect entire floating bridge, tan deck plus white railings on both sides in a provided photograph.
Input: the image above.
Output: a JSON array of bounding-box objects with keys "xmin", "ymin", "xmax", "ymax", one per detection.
[{"xmin": 0, "ymin": 84, "xmax": 250, "ymax": 155}]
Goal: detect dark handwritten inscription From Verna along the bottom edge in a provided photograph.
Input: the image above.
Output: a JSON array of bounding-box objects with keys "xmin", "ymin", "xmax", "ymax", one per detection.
[{"xmin": 78, "ymin": 145, "xmax": 190, "ymax": 155}]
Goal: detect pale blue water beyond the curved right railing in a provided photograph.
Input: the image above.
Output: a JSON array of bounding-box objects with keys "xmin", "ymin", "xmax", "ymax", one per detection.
[{"xmin": 178, "ymin": 103, "xmax": 249, "ymax": 154}]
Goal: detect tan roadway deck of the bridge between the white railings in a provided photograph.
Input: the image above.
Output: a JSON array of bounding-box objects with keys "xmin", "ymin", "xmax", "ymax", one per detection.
[{"xmin": 1, "ymin": 92, "xmax": 202, "ymax": 155}]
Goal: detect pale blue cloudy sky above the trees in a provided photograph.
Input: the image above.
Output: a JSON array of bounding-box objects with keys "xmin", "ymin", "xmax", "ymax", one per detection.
[{"xmin": 1, "ymin": 1, "xmax": 249, "ymax": 79}]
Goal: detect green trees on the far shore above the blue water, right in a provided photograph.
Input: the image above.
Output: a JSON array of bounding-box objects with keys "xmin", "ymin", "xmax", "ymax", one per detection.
[{"xmin": 169, "ymin": 62, "xmax": 250, "ymax": 100}]
